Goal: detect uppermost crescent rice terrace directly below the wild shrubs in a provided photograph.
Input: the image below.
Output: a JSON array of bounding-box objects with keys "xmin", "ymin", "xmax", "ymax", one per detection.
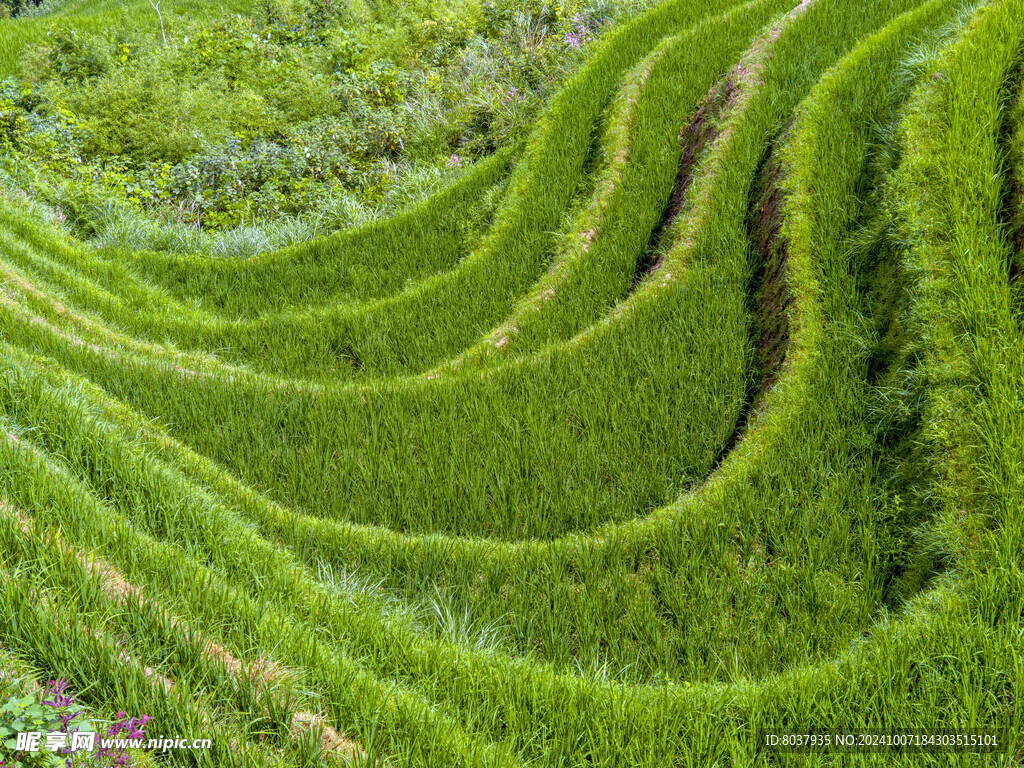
[{"xmin": 0, "ymin": 152, "xmax": 509, "ymax": 319}]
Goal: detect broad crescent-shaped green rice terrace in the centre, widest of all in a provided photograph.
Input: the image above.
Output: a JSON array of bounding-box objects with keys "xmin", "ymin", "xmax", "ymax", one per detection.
[{"xmin": 0, "ymin": 0, "xmax": 770, "ymax": 539}]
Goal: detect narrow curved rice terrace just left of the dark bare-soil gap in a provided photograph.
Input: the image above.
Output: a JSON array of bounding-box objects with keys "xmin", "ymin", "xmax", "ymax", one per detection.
[{"xmin": 432, "ymin": 3, "xmax": 776, "ymax": 371}]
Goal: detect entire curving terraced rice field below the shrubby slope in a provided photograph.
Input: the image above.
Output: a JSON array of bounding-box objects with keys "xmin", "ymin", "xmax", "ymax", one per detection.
[{"xmin": 0, "ymin": 0, "xmax": 1024, "ymax": 766}]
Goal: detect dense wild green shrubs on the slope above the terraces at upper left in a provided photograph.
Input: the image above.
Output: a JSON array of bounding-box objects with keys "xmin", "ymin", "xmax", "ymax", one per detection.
[{"xmin": 4, "ymin": 0, "xmax": 614, "ymax": 233}]
